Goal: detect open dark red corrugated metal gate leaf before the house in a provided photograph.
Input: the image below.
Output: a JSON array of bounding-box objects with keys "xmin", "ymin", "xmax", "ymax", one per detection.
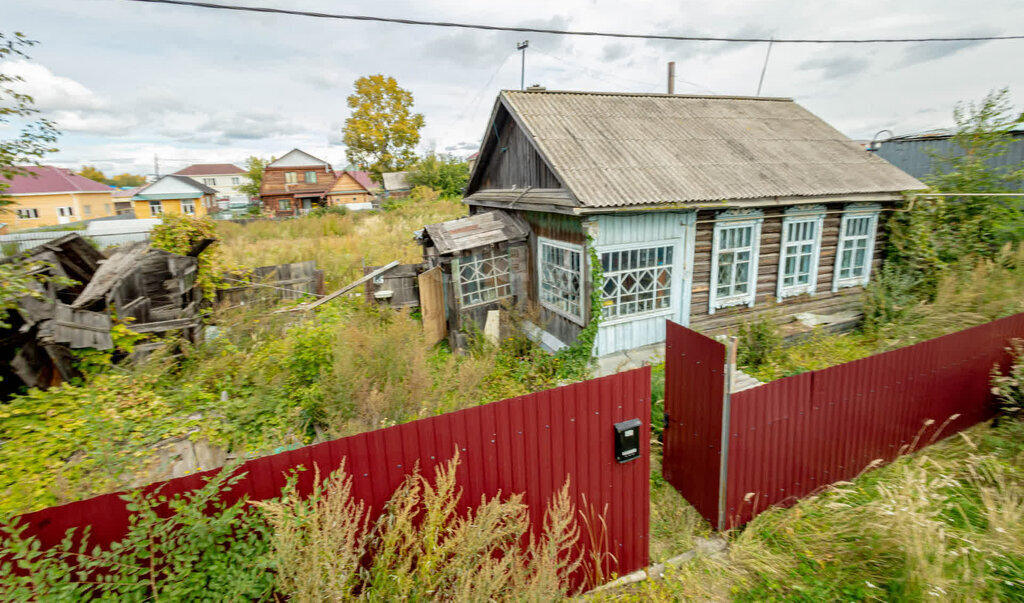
[{"xmin": 662, "ymin": 322, "xmax": 725, "ymax": 525}]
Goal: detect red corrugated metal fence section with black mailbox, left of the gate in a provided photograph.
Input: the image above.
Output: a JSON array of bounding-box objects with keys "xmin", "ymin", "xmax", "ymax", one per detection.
[{"xmin": 14, "ymin": 369, "xmax": 650, "ymax": 574}]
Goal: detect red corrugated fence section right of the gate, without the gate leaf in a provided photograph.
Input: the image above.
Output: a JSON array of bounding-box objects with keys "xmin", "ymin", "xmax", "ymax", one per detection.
[{"xmin": 724, "ymin": 314, "xmax": 1024, "ymax": 527}]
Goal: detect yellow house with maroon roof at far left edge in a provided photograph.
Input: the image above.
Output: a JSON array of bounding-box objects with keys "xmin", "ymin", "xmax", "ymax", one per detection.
[{"xmin": 0, "ymin": 166, "xmax": 115, "ymax": 231}]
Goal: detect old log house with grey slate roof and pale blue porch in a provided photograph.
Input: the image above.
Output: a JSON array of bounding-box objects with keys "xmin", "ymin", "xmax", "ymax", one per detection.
[{"xmin": 444, "ymin": 91, "xmax": 924, "ymax": 355}]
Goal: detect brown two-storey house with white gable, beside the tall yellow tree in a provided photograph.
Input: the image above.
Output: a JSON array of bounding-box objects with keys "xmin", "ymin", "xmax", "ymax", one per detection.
[{"xmin": 259, "ymin": 148, "xmax": 338, "ymax": 216}]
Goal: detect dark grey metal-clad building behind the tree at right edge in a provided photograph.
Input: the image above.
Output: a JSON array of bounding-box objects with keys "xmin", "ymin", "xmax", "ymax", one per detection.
[{"xmin": 870, "ymin": 130, "xmax": 1024, "ymax": 190}]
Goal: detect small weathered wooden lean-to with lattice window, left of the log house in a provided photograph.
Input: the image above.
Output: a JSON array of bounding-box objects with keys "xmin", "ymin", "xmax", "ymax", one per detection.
[{"xmin": 417, "ymin": 210, "xmax": 529, "ymax": 348}]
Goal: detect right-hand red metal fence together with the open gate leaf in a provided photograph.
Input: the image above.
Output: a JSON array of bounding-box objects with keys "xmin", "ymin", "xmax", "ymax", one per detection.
[{"xmin": 663, "ymin": 314, "xmax": 1024, "ymax": 528}]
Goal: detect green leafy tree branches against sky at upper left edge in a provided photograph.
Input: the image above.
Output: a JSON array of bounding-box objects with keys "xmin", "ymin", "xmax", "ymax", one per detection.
[{"xmin": 0, "ymin": 32, "xmax": 60, "ymax": 211}]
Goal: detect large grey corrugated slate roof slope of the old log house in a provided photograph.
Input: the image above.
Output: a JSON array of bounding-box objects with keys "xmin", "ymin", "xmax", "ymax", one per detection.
[{"xmin": 501, "ymin": 90, "xmax": 925, "ymax": 207}]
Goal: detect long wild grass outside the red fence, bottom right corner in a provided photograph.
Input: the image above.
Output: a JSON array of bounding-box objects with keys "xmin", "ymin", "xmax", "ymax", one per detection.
[{"xmin": 594, "ymin": 420, "xmax": 1024, "ymax": 602}]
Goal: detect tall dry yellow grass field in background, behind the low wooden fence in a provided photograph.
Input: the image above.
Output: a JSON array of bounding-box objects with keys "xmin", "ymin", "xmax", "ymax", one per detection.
[{"xmin": 217, "ymin": 199, "xmax": 466, "ymax": 291}]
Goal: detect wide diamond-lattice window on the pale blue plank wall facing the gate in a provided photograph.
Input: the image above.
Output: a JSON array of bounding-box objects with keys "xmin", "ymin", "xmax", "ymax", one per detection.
[{"xmin": 601, "ymin": 245, "xmax": 675, "ymax": 319}]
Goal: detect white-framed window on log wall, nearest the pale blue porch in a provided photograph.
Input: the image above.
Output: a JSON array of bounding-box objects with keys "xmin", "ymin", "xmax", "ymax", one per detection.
[{"xmin": 708, "ymin": 211, "xmax": 763, "ymax": 314}]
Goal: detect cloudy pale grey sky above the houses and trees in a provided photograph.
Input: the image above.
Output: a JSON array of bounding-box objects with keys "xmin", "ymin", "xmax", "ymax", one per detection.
[{"xmin": 0, "ymin": 0, "xmax": 1024, "ymax": 175}]
